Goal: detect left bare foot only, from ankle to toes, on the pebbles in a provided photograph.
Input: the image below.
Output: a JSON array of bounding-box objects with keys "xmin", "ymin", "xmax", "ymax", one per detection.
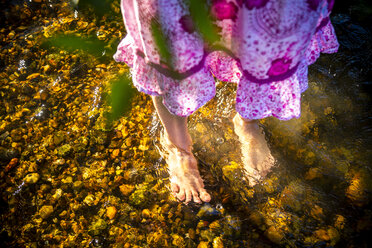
[{"xmin": 160, "ymin": 134, "xmax": 211, "ymax": 203}]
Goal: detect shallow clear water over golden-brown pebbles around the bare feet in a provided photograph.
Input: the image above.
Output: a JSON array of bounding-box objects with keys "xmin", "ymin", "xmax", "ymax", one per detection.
[{"xmin": 0, "ymin": 0, "xmax": 372, "ymax": 248}]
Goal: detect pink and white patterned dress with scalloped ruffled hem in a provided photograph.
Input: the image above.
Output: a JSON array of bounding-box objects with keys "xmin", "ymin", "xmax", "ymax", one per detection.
[{"xmin": 114, "ymin": 0, "xmax": 338, "ymax": 120}]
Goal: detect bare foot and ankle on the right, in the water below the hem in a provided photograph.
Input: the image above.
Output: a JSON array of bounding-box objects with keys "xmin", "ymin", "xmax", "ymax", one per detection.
[{"xmin": 233, "ymin": 114, "xmax": 274, "ymax": 186}]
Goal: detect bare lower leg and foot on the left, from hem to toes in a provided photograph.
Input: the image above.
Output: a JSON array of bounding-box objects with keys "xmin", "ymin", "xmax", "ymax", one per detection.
[{"xmin": 152, "ymin": 97, "xmax": 210, "ymax": 203}]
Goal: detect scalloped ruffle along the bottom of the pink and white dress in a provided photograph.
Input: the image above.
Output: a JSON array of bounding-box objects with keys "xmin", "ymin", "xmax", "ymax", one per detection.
[{"xmin": 114, "ymin": 17, "xmax": 338, "ymax": 120}]
